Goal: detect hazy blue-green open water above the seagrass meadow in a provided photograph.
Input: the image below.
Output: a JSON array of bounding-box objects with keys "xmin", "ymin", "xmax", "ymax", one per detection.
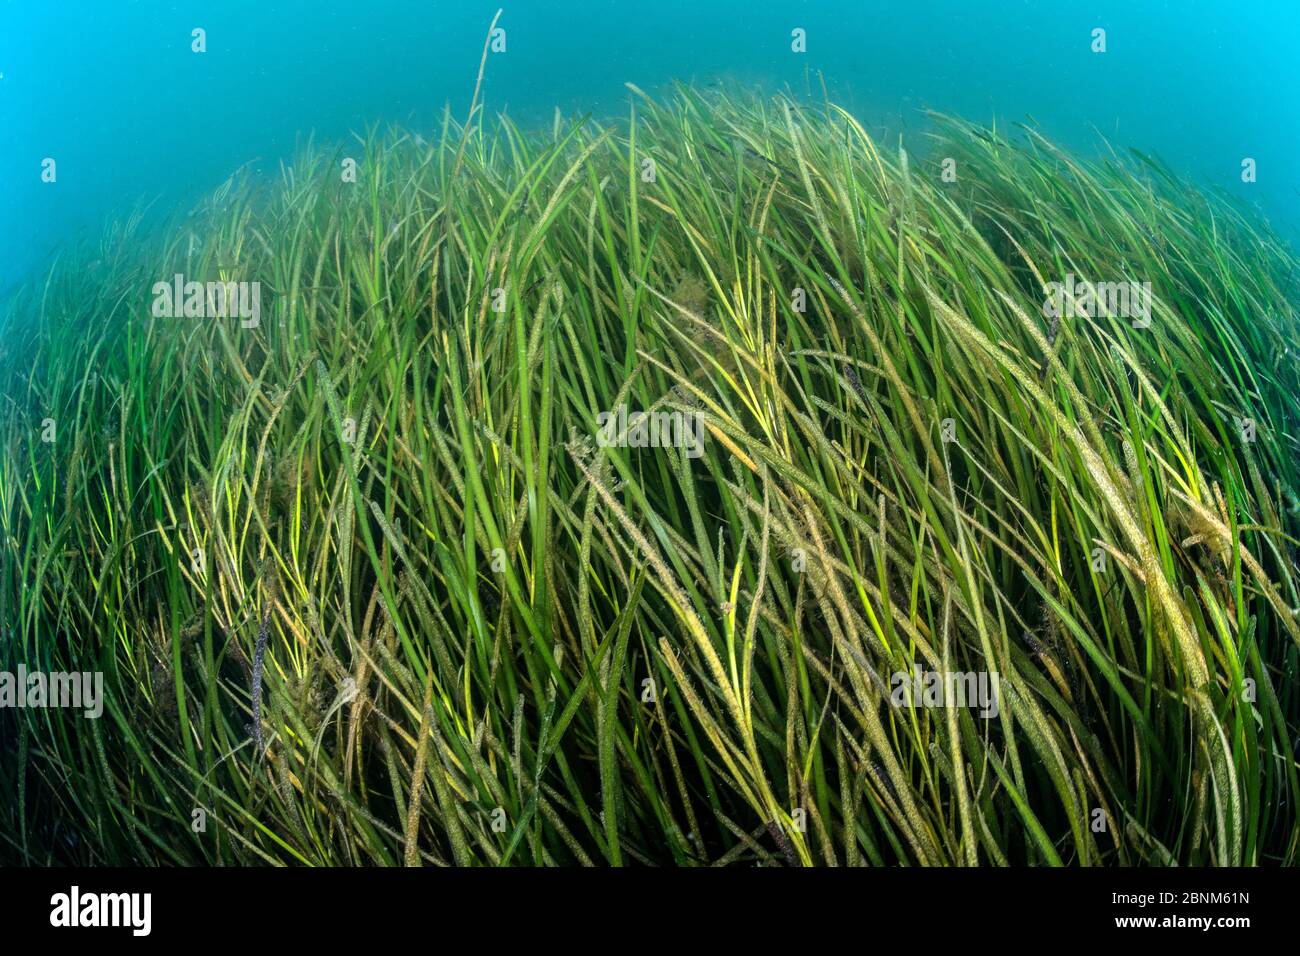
[{"xmin": 0, "ymin": 0, "xmax": 1300, "ymax": 286}]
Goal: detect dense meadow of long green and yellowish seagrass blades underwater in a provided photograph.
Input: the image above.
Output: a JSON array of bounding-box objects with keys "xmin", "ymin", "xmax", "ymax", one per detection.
[{"xmin": 0, "ymin": 86, "xmax": 1300, "ymax": 866}]
